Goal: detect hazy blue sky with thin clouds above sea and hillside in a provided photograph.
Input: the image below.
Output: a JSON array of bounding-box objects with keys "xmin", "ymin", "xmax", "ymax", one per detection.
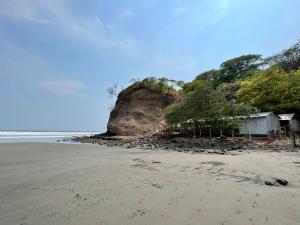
[{"xmin": 0, "ymin": 0, "xmax": 300, "ymax": 132}]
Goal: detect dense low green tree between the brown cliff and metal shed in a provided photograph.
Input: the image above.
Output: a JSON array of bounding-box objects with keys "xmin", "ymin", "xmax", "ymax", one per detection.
[{"xmin": 165, "ymin": 80, "xmax": 253, "ymax": 132}]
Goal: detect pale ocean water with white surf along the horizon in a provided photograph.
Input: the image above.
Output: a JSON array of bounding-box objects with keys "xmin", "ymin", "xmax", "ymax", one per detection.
[{"xmin": 0, "ymin": 131, "xmax": 99, "ymax": 143}]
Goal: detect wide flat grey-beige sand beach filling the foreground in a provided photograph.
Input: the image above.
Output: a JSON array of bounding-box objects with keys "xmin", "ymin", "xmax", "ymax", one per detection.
[{"xmin": 0, "ymin": 143, "xmax": 300, "ymax": 225}]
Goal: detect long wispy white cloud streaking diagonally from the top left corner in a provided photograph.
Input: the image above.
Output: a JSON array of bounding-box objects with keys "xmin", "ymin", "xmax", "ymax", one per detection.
[{"xmin": 0, "ymin": 0, "xmax": 138, "ymax": 56}]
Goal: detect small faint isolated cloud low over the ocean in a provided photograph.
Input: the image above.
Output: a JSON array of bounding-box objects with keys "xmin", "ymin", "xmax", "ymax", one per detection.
[{"xmin": 37, "ymin": 80, "xmax": 86, "ymax": 96}]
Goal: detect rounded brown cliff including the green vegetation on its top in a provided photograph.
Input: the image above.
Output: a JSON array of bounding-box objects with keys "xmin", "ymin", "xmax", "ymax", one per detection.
[{"xmin": 107, "ymin": 77, "xmax": 179, "ymax": 136}]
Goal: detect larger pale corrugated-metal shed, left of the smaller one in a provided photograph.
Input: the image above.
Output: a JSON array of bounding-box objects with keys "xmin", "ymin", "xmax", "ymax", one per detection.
[{"xmin": 240, "ymin": 112, "xmax": 280, "ymax": 135}]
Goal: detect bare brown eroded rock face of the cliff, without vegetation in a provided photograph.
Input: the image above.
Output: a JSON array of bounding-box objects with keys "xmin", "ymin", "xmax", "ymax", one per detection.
[{"xmin": 107, "ymin": 88, "xmax": 178, "ymax": 136}]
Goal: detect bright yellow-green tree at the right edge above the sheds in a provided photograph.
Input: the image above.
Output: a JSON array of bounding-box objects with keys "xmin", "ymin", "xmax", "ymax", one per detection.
[{"xmin": 237, "ymin": 66, "xmax": 300, "ymax": 112}]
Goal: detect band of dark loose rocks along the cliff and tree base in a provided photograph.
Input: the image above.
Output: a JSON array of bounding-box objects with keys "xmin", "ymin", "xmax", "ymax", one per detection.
[{"xmin": 71, "ymin": 135, "xmax": 299, "ymax": 154}]
